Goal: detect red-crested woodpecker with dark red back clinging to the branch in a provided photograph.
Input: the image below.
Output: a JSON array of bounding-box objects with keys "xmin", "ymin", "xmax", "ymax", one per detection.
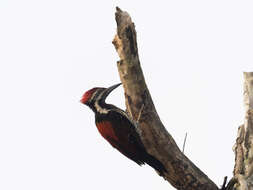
[{"xmin": 81, "ymin": 83, "xmax": 167, "ymax": 176}]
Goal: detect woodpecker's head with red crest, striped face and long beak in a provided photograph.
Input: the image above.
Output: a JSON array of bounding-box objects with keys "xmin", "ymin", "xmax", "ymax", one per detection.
[{"xmin": 80, "ymin": 83, "xmax": 121, "ymax": 108}]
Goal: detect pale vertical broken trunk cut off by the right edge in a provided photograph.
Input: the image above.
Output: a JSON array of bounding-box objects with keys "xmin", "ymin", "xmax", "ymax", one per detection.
[{"xmin": 234, "ymin": 72, "xmax": 253, "ymax": 190}]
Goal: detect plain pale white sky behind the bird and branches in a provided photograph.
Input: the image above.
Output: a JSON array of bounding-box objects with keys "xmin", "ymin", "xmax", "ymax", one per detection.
[{"xmin": 0, "ymin": 0, "xmax": 253, "ymax": 190}]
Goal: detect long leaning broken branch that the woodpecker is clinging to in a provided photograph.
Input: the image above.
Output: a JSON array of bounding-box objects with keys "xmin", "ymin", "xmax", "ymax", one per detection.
[{"xmin": 113, "ymin": 8, "xmax": 218, "ymax": 190}]
